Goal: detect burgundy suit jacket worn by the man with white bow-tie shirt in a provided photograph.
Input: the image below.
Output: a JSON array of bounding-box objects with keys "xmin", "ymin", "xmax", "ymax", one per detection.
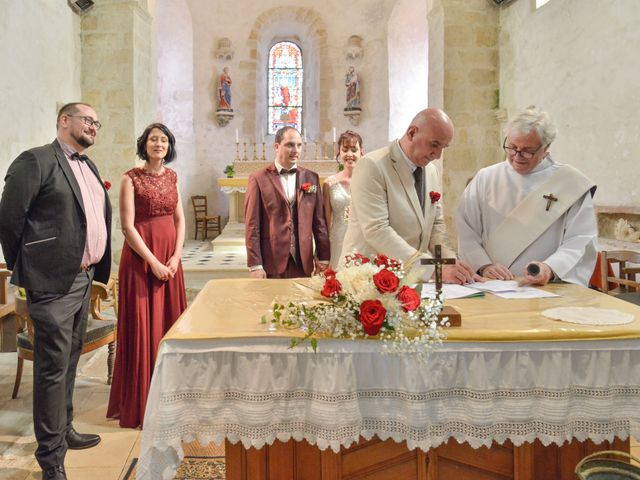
[{"xmin": 244, "ymin": 164, "xmax": 330, "ymax": 276}]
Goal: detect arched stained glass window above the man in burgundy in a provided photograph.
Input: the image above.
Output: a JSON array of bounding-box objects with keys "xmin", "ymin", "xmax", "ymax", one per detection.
[{"xmin": 267, "ymin": 42, "xmax": 303, "ymax": 134}]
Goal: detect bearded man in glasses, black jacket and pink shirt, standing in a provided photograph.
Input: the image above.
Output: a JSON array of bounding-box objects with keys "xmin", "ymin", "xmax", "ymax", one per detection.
[{"xmin": 0, "ymin": 103, "xmax": 111, "ymax": 480}]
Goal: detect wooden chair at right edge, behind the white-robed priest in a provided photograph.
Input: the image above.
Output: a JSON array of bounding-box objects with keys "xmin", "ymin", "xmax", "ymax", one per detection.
[{"xmin": 600, "ymin": 250, "xmax": 640, "ymax": 304}]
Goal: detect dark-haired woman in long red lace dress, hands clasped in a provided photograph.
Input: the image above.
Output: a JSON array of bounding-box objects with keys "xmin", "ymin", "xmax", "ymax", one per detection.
[{"xmin": 107, "ymin": 123, "xmax": 187, "ymax": 428}]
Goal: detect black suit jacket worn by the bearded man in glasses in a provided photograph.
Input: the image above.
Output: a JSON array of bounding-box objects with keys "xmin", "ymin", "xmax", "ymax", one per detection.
[{"xmin": 0, "ymin": 140, "xmax": 111, "ymax": 293}]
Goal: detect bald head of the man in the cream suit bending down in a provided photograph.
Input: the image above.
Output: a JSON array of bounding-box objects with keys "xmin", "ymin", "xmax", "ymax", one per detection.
[{"xmin": 400, "ymin": 108, "xmax": 453, "ymax": 167}]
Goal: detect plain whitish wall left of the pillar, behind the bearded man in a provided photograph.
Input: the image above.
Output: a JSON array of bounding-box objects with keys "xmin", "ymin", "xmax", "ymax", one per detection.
[{"xmin": 0, "ymin": 1, "xmax": 82, "ymax": 185}]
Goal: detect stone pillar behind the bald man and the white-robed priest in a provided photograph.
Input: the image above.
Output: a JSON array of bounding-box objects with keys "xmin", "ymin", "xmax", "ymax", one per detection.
[{"xmin": 427, "ymin": 0, "xmax": 502, "ymax": 240}]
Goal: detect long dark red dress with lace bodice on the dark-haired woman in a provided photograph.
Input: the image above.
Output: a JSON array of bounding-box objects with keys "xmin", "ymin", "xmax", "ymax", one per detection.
[{"xmin": 107, "ymin": 168, "xmax": 187, "ymax": 428}]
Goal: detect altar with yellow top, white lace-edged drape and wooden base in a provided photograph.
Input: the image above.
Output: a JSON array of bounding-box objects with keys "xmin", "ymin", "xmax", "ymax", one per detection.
[{"xmin": 136, "ymin": 279, "xmax": 640, "ymax": 480}]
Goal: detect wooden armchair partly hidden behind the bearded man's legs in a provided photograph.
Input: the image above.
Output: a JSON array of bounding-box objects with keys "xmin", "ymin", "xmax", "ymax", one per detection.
[{"xmin": 11, "ymin": 279, "xmax": 118, "ymax": 398}]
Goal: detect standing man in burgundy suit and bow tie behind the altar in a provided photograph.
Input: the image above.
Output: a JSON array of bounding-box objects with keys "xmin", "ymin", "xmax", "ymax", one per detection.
[{"xmin": 244, "ymin": 127, "xmax": 330, "ymax": 278}]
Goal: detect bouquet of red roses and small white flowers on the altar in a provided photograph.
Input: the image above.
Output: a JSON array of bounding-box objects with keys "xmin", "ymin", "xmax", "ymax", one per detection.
[{"xmin": 263, "ymin": 253, "xmax": 448, "ymax": 354}]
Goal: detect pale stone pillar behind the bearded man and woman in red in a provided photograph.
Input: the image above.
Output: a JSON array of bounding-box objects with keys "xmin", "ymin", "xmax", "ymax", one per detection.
[{"xmin": 81, "ymin": 0, "xmax": 154, "ymax": 263}]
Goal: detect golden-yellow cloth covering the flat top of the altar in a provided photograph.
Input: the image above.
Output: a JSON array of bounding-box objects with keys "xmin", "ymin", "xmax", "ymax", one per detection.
[{"xmin": 165, "ymin": 279, "xmax": 640, "ymax": 342}]
